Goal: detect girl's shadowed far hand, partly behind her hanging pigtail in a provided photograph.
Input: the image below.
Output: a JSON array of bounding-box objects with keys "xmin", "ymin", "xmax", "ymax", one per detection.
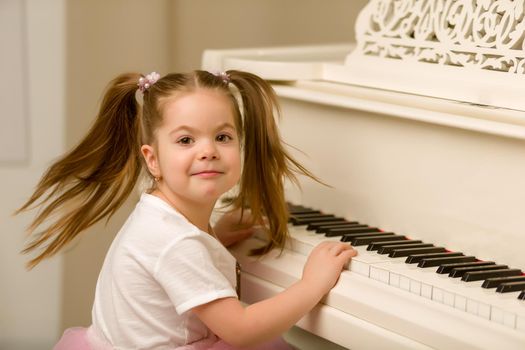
[{"xmin": 214, "ymin": 209, "xmax": 254, "ymax": 247}]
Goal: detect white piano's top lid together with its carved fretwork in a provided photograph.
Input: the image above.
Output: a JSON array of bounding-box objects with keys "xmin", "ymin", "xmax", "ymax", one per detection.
[{"xmin": 203, "ymin": 0, "xmax": 525, "ymax": 111}]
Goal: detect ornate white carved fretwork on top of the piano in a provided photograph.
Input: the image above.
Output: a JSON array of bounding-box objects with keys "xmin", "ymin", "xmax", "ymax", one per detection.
[{"xmin": 350, "ymin": 0, "xmax": 525, "ymax": 74}]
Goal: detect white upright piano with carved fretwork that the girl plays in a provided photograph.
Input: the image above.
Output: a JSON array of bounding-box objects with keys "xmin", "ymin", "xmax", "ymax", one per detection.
[{"xmin": 203, "ymin": 0, "xmax": 525, "ymax": 349}]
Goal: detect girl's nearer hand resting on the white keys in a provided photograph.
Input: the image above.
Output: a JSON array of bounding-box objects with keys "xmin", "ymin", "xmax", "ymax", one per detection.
[{"xmin": 302, "ymin": 242, "xmax": 357, "ymax": 295}]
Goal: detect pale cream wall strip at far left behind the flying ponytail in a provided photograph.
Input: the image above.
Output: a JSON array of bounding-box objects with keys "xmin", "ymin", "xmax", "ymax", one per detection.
[{"xmin": 0, "ymin": 0, "xmax": 65, "ymax": 350}]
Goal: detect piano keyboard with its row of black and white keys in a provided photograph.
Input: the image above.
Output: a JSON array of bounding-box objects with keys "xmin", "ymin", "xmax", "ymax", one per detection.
[{"xmin": 289, "ymin": 205, "xmax": 525, "ymax": 304}]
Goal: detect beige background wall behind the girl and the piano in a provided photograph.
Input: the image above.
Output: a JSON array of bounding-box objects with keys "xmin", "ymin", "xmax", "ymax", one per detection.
[{"xmin": 0, "ymin": 0, "xmax": 366, "ymax": 350}]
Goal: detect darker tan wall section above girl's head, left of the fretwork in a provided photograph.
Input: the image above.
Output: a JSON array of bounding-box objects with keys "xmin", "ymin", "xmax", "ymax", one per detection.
[{"xmin": 169, "ymin": 0, "xmax": 367, "ymax": 71}]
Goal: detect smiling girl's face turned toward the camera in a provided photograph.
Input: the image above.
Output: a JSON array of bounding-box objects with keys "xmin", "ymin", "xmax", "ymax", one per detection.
[{"xmin": 142, "ymin": 89, "xmax": 241, "ymax": 205}]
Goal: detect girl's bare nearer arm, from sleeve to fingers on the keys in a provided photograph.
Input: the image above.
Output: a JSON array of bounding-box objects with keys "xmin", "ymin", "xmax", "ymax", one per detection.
[{"xmin": 193, "ymin": 242, "xmax": 356, "ymax": 347}]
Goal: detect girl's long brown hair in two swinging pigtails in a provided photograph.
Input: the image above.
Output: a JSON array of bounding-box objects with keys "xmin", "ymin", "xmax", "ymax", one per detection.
[{"xmin": 16, "ymin": 70, "xmax": 317, "ymax": 268}]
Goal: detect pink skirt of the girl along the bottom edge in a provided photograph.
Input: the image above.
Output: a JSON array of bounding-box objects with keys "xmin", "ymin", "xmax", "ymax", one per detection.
[{"xmin": 53, "ymin": 327, "xmax": 293, "ymax": 350}]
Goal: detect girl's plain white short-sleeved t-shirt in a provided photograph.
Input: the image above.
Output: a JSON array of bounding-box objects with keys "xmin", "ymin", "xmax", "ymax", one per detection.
[{"xmin": 92, "ymin": 194, "xmax": 236, "ymax": 350}]
